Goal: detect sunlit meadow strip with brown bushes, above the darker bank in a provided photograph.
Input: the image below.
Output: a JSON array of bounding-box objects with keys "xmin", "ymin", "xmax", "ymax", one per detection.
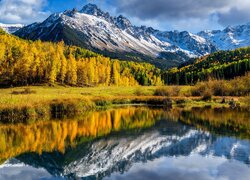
[{"xmin": 0, "ymin": 86, "xmax": 249, "ymax": 109}]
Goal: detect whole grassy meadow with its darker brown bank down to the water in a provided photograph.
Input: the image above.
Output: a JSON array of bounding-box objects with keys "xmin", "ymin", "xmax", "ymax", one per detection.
[{"xmin": 0, "ymin": 86, "xmax": 250, "ymax": 123}]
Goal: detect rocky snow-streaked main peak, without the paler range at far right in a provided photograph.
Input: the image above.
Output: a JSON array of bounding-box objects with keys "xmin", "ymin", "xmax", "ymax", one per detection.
[{"xmin": 13, "ymin": 4, "xmax": 219, "ymax": 58}]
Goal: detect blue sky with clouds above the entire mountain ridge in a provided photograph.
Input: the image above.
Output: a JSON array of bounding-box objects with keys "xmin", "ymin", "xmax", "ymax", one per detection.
[{"xmin": 0, "ymin": 0, "xmax": 250, "ymax": 32}]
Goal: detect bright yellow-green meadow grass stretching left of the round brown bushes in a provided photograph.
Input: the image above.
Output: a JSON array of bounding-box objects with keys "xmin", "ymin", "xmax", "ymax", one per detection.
[{"xmin": 0, "ymin": 86, "xmax": 156, "ymax": 109}]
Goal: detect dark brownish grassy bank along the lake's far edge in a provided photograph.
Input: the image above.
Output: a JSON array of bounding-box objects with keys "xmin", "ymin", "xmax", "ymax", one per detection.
[{"xmin": 0, "ymin": 93, "xmax": 250, "ymax": 124}]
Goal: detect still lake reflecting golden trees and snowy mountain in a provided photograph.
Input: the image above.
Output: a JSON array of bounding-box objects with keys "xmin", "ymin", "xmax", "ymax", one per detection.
[{"xmin": 0, "ymin": 106, "xmax": 250, "ymax": 180}]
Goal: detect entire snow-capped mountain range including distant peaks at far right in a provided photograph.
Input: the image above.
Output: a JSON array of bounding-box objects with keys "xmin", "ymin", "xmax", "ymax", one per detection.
[{"xmin": 15, "ymin": 4, "xmax": 250, "ymax": 67}]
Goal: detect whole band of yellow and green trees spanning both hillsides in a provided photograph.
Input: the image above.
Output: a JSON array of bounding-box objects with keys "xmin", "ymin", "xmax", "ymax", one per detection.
[{"xmin": 0, "ymin": 29, "xmax": 250, "ymax": 87}]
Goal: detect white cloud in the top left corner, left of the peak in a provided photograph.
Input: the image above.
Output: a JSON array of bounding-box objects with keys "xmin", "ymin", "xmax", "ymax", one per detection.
[{"xmin": 0, "ymin": 0, "xmax": 49, "ymax": 24}]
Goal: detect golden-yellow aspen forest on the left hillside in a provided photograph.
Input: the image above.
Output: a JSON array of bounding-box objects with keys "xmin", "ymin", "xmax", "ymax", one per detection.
[{"xmin": 0, "ymin": 30, "xmax": 162, "ymax": 87}]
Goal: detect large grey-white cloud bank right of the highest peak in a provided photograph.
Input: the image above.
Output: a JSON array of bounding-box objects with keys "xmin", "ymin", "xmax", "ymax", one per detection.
[{"xmin": 110, "ymin": 0, "xmax": 250, "ymax": 32}]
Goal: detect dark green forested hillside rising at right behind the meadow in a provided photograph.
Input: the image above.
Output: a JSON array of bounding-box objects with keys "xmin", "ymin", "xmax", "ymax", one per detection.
[{"xmin": 162, "ymin": 47, "xmax": 250, "ymax": 85}]
